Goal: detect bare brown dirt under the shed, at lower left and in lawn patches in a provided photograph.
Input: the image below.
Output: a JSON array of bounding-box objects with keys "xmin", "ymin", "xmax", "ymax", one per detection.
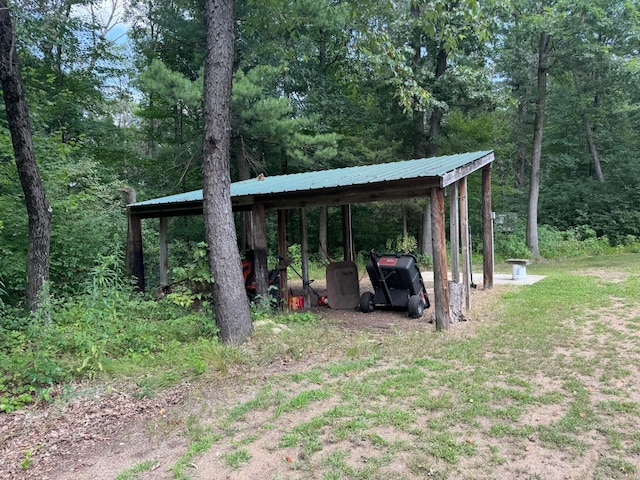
[{"xmin": 0, "ymin": 270, "xmax": 640, "ymax": 480}]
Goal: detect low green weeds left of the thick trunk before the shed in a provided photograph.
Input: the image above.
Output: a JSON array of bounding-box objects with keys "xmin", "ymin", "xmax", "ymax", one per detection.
[{"xmin": 0, "ymin": 256, "xmax": 217, "ymax": 411}]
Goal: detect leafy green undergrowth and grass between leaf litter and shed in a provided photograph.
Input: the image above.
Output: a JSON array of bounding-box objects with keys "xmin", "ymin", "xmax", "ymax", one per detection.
[{"xmin": 0, "ymin": 257, "xmax": 314, "ymax": 412}]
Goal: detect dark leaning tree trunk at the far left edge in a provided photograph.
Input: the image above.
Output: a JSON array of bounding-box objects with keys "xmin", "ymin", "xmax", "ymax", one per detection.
[{"xmin": 0, "ymin": 0, "xmax": 51, "ymax": 310}]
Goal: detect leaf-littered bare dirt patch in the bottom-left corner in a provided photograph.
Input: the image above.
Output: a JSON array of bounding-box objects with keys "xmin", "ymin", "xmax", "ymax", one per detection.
[{"xmin": 0, "ymin": 385, "xmax": 186, "ymax": 479}]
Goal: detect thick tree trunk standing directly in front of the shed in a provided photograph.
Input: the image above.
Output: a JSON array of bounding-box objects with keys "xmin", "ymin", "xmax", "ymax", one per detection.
[{"xmin": 202, "ymin": 0, "xmax": 253, "ymax": 345}]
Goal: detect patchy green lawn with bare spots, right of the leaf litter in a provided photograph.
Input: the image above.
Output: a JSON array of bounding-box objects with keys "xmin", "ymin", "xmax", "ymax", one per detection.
[{"xmin": 140, "ymin": 255, "xmax": 640, "ymax": 479}]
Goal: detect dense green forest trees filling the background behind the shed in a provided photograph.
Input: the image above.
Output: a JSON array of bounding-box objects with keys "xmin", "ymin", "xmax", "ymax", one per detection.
[{"xmin": 0, "ymin": 0, "xmax": 640, "ymax": 304}]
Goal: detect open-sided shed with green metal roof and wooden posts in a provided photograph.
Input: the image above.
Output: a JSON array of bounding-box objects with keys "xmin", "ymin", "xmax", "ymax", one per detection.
[{"xmin": 127, "ymin": 150, "xmax": 494, "ymax": 329}]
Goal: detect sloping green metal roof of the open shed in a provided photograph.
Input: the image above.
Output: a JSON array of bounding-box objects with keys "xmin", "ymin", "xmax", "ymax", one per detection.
[{"xmin": 128, "ymin": 150, "xmax": 493, "ymax": 216}]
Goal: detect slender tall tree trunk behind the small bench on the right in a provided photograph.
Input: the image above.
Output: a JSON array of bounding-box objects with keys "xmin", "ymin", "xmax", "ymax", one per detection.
[{"xmin": 527, "ymin": 32, "xmax": 551, "ymax": 258}]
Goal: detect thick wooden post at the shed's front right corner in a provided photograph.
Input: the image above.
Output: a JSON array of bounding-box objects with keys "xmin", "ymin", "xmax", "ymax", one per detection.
[{"xmin": 431, "ymin": 188, "xmax": 451, "ymax": 330}]
